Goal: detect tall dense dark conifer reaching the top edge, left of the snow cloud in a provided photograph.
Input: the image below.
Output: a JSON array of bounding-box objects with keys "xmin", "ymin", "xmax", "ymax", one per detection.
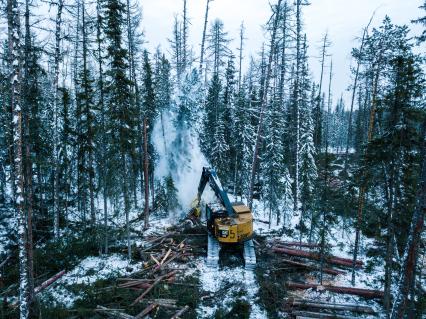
[{"xmin": 104, "ymin": 0, "xmax": 136, "ymax": 260}]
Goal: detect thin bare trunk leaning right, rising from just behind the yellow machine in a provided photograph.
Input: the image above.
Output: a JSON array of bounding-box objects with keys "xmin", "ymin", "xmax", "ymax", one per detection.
[{"xmin": 248, "ymin": 0, "xmax": 282, "ymax": 209}]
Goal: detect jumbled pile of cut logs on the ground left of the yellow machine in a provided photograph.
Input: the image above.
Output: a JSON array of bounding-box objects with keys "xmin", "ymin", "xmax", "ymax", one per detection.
[{"xmin": 96, "ymin": 233, "xmax": 193, "ymax": 319}]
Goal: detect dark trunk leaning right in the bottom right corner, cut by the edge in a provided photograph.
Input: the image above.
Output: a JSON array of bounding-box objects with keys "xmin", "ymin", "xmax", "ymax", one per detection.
[{"xmin": 391, "ymin": 120, "xmax": 426, "ymax": 319}]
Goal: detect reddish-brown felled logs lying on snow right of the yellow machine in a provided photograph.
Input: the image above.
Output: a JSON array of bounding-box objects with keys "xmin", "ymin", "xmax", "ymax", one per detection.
[{"xmin": 271, "ymin": 241, "xmax": 384, "ymax": 302}]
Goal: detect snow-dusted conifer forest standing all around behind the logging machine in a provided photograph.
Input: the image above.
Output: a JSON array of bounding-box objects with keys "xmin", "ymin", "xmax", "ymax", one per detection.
[{"xmin": 0, "ymin": 0, "xmax": 425, "ymax": 318}]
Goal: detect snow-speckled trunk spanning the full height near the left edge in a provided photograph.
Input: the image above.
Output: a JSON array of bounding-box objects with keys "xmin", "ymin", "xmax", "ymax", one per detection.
[{"xmin": 7, "ymin": 0, "xmax": 29, "ymax": 319}]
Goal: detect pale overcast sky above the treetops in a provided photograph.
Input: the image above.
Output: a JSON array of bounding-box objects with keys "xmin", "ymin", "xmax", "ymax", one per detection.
[{"xmin": 139, "ymin": 0, "xmax": 426, "ymax": 109}]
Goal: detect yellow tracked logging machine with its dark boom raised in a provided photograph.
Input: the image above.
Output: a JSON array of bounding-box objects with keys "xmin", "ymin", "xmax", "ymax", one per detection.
[{"xmin": 190, "ymin": 167, "xmax": 256, "ymax": 269}]
